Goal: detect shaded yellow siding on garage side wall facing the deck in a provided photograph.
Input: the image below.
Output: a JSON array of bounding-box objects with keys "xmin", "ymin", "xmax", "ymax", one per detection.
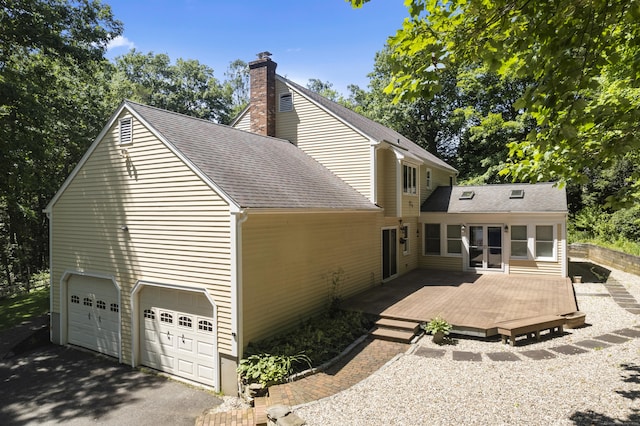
[{"xmin": 242, "ymin": 213, "xmax": 381, "ymax": 346}]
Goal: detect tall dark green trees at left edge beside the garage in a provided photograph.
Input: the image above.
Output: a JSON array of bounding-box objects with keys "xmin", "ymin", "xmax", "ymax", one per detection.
[{"xmin": 0, "ymin": 0, "xmax": 122, "ymax": 285}]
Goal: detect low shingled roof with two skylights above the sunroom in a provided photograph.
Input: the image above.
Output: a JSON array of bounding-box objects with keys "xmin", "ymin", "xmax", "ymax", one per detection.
[{"xmin": 420, "ymin": 183, "xmax": 567, "ymax": 213}]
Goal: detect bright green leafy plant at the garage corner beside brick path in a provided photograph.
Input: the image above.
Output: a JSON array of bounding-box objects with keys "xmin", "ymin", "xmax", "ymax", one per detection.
[{"xmin": 237, "ymin": 353, "xmax": 311, "ymax": 387}]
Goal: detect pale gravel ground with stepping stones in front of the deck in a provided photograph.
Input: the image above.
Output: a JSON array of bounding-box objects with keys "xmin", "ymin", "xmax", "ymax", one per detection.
[{"xmin": 295, "ymin": 262, "xmax": 640, "ymax": 426}]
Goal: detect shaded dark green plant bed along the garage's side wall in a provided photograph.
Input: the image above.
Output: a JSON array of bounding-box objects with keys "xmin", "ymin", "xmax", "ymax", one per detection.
[{"xmin": 245, "ymin": 311, "xmax": 372, "ymax": 372}]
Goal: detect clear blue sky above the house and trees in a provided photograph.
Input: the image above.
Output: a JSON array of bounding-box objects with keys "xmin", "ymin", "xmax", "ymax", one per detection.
[{"xmin": 104, "ymin": 0, "xmax": 408, "ymax": 95}]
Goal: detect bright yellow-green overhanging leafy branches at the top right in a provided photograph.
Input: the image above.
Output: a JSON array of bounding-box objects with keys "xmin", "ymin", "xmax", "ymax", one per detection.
[{"xmin": 350, "ymin": 0, "xmax": 640, "ymax": 206}]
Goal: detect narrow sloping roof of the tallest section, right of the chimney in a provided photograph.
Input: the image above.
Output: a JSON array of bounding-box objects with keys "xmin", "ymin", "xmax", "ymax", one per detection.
[{"xmin": 277, "ymin": 75, "xmax": 458, "ymax": 173}]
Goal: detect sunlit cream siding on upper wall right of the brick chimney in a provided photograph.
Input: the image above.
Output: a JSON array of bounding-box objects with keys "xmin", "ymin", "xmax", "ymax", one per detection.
[{"xmin": 276, "ymin": 81, "xmax": 371, "ymax": 198}]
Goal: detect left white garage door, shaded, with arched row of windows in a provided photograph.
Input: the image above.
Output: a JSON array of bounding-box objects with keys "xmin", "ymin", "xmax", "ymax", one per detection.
[{"xmin": 67, "ymin": 275, "xmax": 120, "ymax": 357}]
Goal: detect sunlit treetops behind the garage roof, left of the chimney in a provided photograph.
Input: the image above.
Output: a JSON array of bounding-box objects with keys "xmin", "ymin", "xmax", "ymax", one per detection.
[{"xmin": 112, "ymin": 49, "xmax": 232, "ymax": 123}]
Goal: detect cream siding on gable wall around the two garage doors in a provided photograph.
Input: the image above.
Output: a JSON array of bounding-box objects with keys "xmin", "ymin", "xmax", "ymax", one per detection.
[{"xmin": 52, "ymin": 111, "xmax": 231, "ymax": 362}]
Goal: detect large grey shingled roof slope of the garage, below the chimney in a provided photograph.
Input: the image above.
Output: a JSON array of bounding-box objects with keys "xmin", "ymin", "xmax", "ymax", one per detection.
[{"xmin": 124, "ymin": 101, "xmax": 378, "ymax": 210}]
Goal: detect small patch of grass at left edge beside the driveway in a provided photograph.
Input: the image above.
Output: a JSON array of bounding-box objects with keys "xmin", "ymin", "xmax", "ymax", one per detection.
[{"xmin": 0, "ymin": 287, "xmax": 49, "ymax": 330}]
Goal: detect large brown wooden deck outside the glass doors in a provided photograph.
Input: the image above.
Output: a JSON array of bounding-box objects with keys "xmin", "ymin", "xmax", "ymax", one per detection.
[{"xmin": 342, "ymin": 269, "xmax": 578, "ymax": 337}]
